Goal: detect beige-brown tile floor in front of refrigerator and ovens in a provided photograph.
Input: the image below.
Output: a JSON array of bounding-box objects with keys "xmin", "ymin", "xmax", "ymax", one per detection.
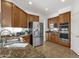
[{"xmin": 36, "ymin": 41, "xmax": 79, "ymax": 58}]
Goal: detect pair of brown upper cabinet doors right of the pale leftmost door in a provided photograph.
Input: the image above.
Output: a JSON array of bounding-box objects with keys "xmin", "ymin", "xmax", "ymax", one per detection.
[{"xmin": 12, "ymin": 5, "xmax": 27, "ymax": 28}]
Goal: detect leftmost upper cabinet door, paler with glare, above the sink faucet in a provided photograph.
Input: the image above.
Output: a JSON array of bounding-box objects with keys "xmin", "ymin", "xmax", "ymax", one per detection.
[{"xmin": 1, "ymin": 0, "xmax": 12, "ymax": 27}]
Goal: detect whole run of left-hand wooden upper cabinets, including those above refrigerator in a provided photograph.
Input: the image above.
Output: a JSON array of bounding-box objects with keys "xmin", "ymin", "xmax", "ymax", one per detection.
[{"xmin": 1, "ymin": 0, "xmax": 39, "ymax": 28}]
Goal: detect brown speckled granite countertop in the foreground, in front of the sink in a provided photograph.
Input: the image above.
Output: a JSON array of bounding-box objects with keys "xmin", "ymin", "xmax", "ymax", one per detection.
[{"xmin": 0, "ymin": 44, "xmax": 45, "ymax": 58}]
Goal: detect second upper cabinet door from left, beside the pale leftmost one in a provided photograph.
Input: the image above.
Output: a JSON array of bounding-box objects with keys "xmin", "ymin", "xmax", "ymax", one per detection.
[{"xmin": 12, "ymin": 5, "xmax": 20, "ymax": 27}]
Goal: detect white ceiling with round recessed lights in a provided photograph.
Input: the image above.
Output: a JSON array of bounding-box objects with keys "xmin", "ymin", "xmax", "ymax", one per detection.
[{"xmin": 11, "ymin": 0, "xmax": 71, "ymax": 15}]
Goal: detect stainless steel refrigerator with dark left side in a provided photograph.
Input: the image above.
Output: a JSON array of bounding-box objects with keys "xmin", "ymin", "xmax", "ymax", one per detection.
[{"xmin": 29, "ymin": 22, "xmax": 43, "ymax": 47}]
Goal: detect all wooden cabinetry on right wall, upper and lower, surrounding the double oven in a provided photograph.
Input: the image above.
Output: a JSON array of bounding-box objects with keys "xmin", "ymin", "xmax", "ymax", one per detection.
[{"xmin": 48, "ymin": 11, "xmax": 71, "ymax": 47}]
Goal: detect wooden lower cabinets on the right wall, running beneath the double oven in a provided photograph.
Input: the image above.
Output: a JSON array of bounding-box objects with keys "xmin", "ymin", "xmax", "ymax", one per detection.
[{"xmin": 48, "ymin": 32, "xmax": 70, "ymax": 48}]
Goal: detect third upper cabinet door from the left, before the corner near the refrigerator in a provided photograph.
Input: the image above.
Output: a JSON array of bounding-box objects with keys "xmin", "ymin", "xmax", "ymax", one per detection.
[{"xmin": 19, "ymin": 10, "xmax": 27, "ymax": 28}]
